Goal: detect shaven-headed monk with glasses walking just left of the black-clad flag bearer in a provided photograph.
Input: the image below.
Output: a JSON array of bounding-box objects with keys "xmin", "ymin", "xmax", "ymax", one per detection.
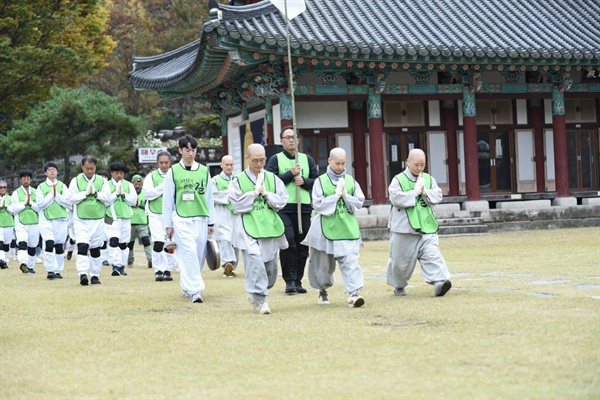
[{"xmin": 229, "ymin": 143, "xmax": 288, "ymax": 314}]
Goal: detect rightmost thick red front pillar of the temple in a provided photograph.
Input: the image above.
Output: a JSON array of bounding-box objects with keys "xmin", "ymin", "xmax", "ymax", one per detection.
[{"xmin": 552, "ymin": 86, "xmax": 569, "ymax": 197}]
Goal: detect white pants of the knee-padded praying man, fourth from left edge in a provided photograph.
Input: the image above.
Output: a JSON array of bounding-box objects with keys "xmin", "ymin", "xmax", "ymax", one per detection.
[{"xmin": 73, "ymin": 216, "xmax": 104, "ymax": 276}]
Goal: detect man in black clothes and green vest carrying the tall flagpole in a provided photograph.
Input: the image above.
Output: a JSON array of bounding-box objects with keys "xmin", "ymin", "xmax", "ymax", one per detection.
[{"xmin": 266, "ymin": 127, "xmax": 319, "ymax": 295}]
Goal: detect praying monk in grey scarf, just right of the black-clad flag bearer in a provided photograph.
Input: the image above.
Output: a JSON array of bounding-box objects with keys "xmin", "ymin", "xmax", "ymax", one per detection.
[{"xmin": 303, "ymin": 147, "xmax": 365, "ymax": 308}]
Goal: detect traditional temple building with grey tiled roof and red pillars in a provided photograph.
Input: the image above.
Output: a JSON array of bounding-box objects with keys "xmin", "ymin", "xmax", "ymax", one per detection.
[{"xmin": 129, "ymin": 0, "xmax": 600, "ymax": 207}]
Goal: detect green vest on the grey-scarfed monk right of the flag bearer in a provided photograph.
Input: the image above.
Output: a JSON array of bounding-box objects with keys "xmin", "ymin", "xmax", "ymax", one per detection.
[{"xmin": 319, "ymin": 174, "xmax": 360, "ymax": 240}]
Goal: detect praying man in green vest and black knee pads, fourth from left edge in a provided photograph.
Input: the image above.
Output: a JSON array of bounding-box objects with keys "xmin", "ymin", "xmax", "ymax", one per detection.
[{"xmin": 69, "ymin": 155, "xmax": 115, "ymax": 286}]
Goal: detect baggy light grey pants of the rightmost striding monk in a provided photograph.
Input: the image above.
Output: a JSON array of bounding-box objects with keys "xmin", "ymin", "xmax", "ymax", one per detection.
[{"xmin": 387, "ymin": 232, "xmax": 450, "ymax": 288}]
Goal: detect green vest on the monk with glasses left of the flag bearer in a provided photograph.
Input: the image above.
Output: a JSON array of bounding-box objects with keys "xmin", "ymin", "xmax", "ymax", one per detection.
[{"xmin": 237, "ymin": 171, "xmax": 285, "ymax": 239}]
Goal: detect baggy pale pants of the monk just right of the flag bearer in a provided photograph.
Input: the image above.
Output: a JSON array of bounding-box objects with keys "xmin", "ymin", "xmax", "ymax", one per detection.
[{"xmin": 308, "ymin": 248, "xmax": 365, "ymax": 294}]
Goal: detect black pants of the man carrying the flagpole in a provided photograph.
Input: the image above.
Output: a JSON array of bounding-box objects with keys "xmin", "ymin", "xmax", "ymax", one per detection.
[{"xmin": 279, "ymin": 213, "xmax": 310, "ymax": 285}]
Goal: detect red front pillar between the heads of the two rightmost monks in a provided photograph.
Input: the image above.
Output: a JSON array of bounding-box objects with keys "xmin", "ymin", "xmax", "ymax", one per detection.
[{"xmin": 368, "ymin": 88, "xmax": 386, "ymax": 204}]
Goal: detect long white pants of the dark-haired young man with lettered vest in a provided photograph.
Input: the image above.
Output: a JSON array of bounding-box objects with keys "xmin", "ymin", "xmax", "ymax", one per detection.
[{"xmin": 173, "ymin": 213, "xmax": 208, "ymax": 296}]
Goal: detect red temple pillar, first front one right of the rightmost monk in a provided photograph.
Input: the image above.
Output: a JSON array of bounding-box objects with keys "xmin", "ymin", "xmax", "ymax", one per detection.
[{"xmin": 463, "ymin": 86, "xmax": 480, "ymax": 201}]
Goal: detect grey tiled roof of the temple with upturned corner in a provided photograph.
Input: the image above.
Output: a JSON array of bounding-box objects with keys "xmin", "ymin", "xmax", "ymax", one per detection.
[{"xmin": 130, "ymin": 0, "xmax": 600, "ymax": 91}]
